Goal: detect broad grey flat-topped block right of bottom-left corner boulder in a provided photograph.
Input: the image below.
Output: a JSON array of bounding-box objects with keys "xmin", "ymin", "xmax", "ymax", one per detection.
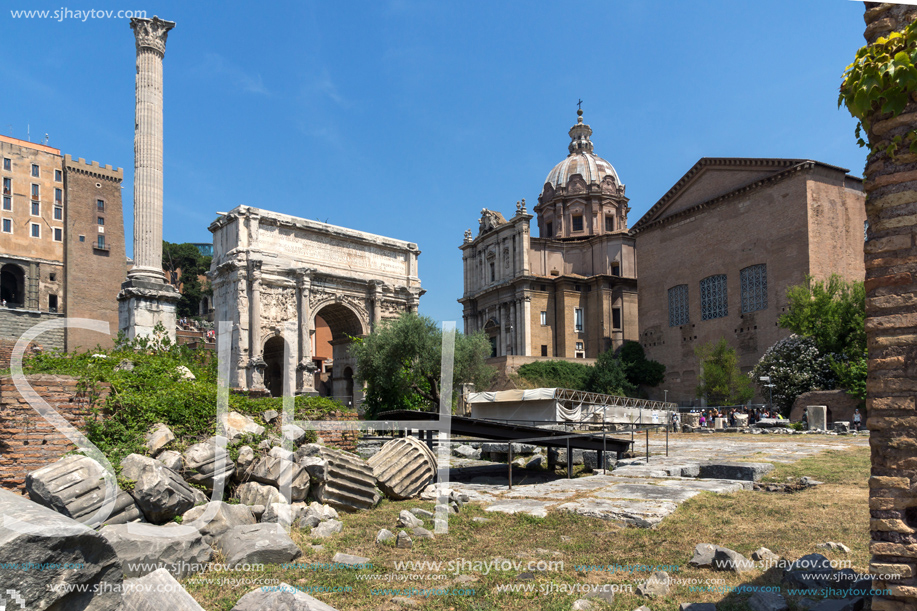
[{"xmin": 99, "ymin": 524, "xmax": 213, "ymax": 579}]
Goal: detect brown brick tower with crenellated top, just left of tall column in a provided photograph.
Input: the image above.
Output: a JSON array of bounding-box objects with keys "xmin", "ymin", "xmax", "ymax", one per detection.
[{"xmin": 64, "ymin": 155, "xmax": 127, "ymax": 351}]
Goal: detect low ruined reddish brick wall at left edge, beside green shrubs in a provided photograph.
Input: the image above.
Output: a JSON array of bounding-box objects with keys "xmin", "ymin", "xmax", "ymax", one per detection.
[{"xmin": 0, "ymin": 375, "xmax": 105, "ymax": 492}]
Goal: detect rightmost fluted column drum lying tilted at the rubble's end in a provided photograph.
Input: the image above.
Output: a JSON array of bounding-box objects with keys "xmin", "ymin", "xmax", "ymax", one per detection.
[{"xmin": 367, "ymin": 437, "xmax": 436, "ymax": 500}]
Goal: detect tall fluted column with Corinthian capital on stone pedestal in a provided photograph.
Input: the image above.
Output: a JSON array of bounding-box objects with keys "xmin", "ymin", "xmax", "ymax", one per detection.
[{"xmin": 118, "ymin": 17, "xmax": 180, "ymax": 342}]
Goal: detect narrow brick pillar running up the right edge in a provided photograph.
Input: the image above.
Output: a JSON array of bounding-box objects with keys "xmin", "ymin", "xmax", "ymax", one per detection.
[{"xmin": 864, "ymin": 2, "xmax": 917, "ymax": 611}]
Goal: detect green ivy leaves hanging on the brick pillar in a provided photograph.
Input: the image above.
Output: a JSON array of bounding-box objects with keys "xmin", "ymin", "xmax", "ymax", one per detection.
[{"xmin": 837, "ymin": 23, "xmax": 917, "ymax": 155}]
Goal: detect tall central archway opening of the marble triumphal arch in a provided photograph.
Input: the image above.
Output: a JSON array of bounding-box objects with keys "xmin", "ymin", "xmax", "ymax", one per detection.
[{"xmin": 312, "ymin": 303, "xmax": 368, "ymax": 405}]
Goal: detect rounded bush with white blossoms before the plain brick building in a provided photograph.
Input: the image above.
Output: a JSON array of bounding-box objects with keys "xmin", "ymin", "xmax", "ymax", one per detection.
[{"xmin": 752, "ymin": 334, "xmax": 837, "ymax": 416}]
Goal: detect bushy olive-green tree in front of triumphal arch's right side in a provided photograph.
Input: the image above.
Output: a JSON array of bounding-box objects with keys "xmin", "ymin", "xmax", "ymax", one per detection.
[{"xmin": 350, "ymin": 313, "xmax": 496, "ymax": 417}]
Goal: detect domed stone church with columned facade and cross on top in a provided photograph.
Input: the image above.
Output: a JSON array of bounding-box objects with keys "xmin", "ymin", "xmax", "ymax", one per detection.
[{"xmin": 459, "ymin": 110, "xmax": 638, "ymax": 361}]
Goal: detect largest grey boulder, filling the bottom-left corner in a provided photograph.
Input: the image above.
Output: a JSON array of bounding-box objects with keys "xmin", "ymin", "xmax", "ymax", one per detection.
[{"xmin": 0, "ymin": 488, "xmax": 123, "ymax": 611}]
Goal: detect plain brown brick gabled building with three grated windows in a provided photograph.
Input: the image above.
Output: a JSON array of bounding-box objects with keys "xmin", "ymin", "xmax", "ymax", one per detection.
[{"xmin": 631, "ymin": 158, "xmax": 866, "ymax": 405}]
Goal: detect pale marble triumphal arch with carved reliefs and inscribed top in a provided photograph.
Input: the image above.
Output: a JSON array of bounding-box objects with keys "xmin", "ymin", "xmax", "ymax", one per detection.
[{"xmin": 209, "ymin": 206, "xmax": 424, "ymax": 404}]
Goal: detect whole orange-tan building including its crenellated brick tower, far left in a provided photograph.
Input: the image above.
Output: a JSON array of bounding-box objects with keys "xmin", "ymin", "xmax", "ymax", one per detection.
[{"xmin": 0, "ymin": 136, "xmax": 126, "ymax": 358}]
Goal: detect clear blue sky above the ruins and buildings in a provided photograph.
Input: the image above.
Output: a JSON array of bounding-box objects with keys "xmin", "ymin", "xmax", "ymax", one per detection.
[{"xmin": 0, "ymin": 0, "xmax": 865, "ymax": 328}]
